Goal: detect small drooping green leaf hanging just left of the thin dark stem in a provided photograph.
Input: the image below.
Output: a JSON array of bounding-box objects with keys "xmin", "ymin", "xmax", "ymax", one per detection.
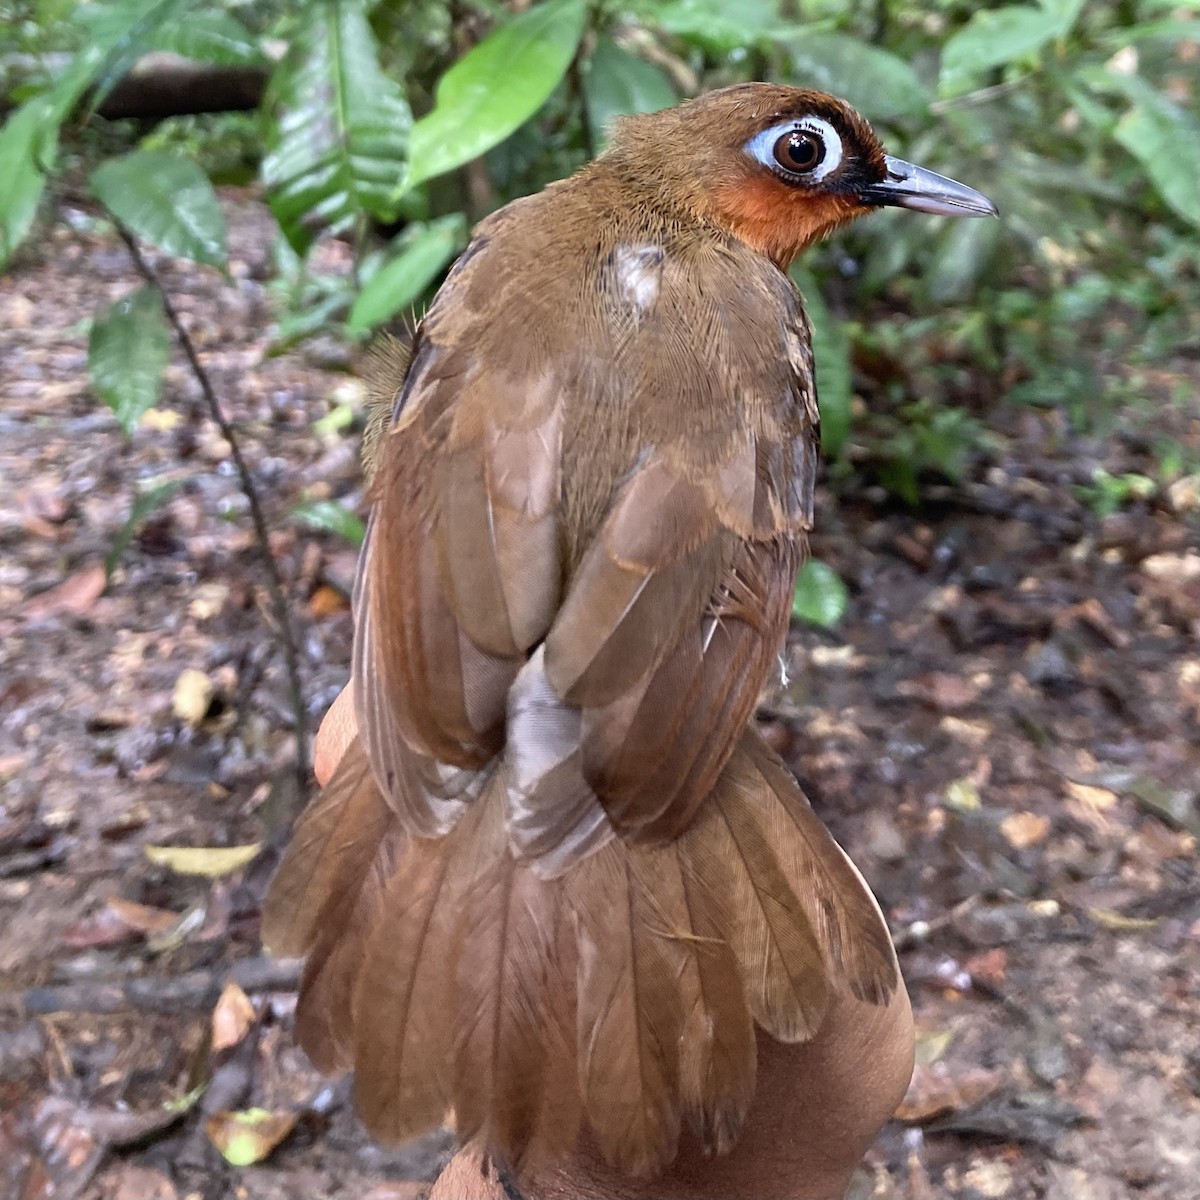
[{"xmin": 88, "ymin": 287, "xmax": 170, "ymax": 437}]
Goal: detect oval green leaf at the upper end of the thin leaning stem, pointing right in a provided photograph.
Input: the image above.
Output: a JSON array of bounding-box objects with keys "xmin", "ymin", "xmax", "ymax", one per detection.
[{"xmin": 90, "ymin": 150, "xmax": 227, "ymax": 266}]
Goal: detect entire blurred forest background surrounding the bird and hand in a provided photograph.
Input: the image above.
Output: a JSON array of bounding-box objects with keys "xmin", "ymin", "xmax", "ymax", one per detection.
[{"xmin": 0, "ymin": 0, "xmax": 1200, "ymax": 1200}]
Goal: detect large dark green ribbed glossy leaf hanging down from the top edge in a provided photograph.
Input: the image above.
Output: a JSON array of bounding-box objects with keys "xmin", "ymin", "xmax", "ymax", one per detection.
[{"xmin": 263, "ymin": 0, "xmax": 412, "ymax": 253}]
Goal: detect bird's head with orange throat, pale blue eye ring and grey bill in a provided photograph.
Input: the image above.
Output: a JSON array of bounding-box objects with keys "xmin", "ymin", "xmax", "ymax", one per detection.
[{"xmin": 606, "ymin": 83, "xmax": 996, "ymax": 268}]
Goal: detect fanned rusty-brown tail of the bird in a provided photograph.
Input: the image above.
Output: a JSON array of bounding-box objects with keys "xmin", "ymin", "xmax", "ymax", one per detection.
[{"xmin": 264, "ymin": 731, "xmax": 899, "ymax": 1175}]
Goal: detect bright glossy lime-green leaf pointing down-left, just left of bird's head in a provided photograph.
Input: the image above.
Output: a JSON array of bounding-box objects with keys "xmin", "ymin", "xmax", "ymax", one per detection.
[{"xmin": 409, "ymin": 0, "xmax": 586, "ymax": 185}]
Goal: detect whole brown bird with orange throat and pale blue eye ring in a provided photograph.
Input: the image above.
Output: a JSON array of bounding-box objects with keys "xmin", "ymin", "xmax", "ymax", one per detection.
[{"xmin": 263, "ymin": 83, "xmax": 996, "ymax": 1177}]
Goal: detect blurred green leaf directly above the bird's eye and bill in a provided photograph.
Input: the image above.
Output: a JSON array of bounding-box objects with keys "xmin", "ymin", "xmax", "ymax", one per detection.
[{"xmin": 782, "ymin": 32, "xmax": 929, "ymax": 120}]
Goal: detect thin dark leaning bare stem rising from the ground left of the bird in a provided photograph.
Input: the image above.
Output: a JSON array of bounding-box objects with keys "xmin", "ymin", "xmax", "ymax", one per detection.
[{"xmin": 115, "ymin": 221, "xmax": 308, "ymax": 792}]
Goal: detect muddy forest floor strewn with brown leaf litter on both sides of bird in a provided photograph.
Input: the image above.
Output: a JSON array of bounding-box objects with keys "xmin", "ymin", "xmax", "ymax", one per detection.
[{"xmin": 0, "ymin": 193, "xmax": 1200, "ymax": 1200}]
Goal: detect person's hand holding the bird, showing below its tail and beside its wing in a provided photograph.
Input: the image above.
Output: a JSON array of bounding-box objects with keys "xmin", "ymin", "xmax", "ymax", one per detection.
[{"xmin": 314, "ymin": 688, "xmax": 913, "ymax": 1200}]
